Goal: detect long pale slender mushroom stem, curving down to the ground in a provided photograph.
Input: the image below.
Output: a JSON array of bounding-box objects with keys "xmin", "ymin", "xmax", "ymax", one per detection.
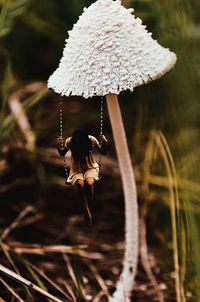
[{"xmin": 106, "ymin": 94, "xmax": 138, "ymax": 302}]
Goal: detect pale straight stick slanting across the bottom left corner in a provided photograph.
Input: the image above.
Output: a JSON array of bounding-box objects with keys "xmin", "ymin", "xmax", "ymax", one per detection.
[{"xmin": 0, "ymin": 264, "xmax": 63, "ymax": 302}]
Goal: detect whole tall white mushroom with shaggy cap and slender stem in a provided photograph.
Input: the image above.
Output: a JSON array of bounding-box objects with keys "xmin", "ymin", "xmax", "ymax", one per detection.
[{"xmin": 48, "ymin": 0, "xmax": 176, "ymax": 302}]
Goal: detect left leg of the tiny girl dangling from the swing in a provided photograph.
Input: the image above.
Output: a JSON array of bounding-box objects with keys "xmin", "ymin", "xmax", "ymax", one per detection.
[{"xmin": 76, "ymin": 179, "xmax": 92, "ymax": 226}]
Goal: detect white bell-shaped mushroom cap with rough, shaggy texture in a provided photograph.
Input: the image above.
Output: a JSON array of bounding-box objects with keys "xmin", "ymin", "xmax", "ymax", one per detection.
[{"xmin": 48, "ymin": 0, "xmax": 176, "ymax": 98}]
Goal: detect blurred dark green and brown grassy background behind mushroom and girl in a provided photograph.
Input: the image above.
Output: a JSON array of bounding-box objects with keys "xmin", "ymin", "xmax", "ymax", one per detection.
[{"xmin": 0, "ymin": 0, "xmax": 200, "ymax": 302}]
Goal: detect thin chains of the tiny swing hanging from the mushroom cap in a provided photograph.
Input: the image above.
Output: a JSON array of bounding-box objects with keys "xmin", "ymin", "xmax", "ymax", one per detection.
[{"xmin": 59, "ymin": 96, "xmax": 104, "ymax": 185}]
